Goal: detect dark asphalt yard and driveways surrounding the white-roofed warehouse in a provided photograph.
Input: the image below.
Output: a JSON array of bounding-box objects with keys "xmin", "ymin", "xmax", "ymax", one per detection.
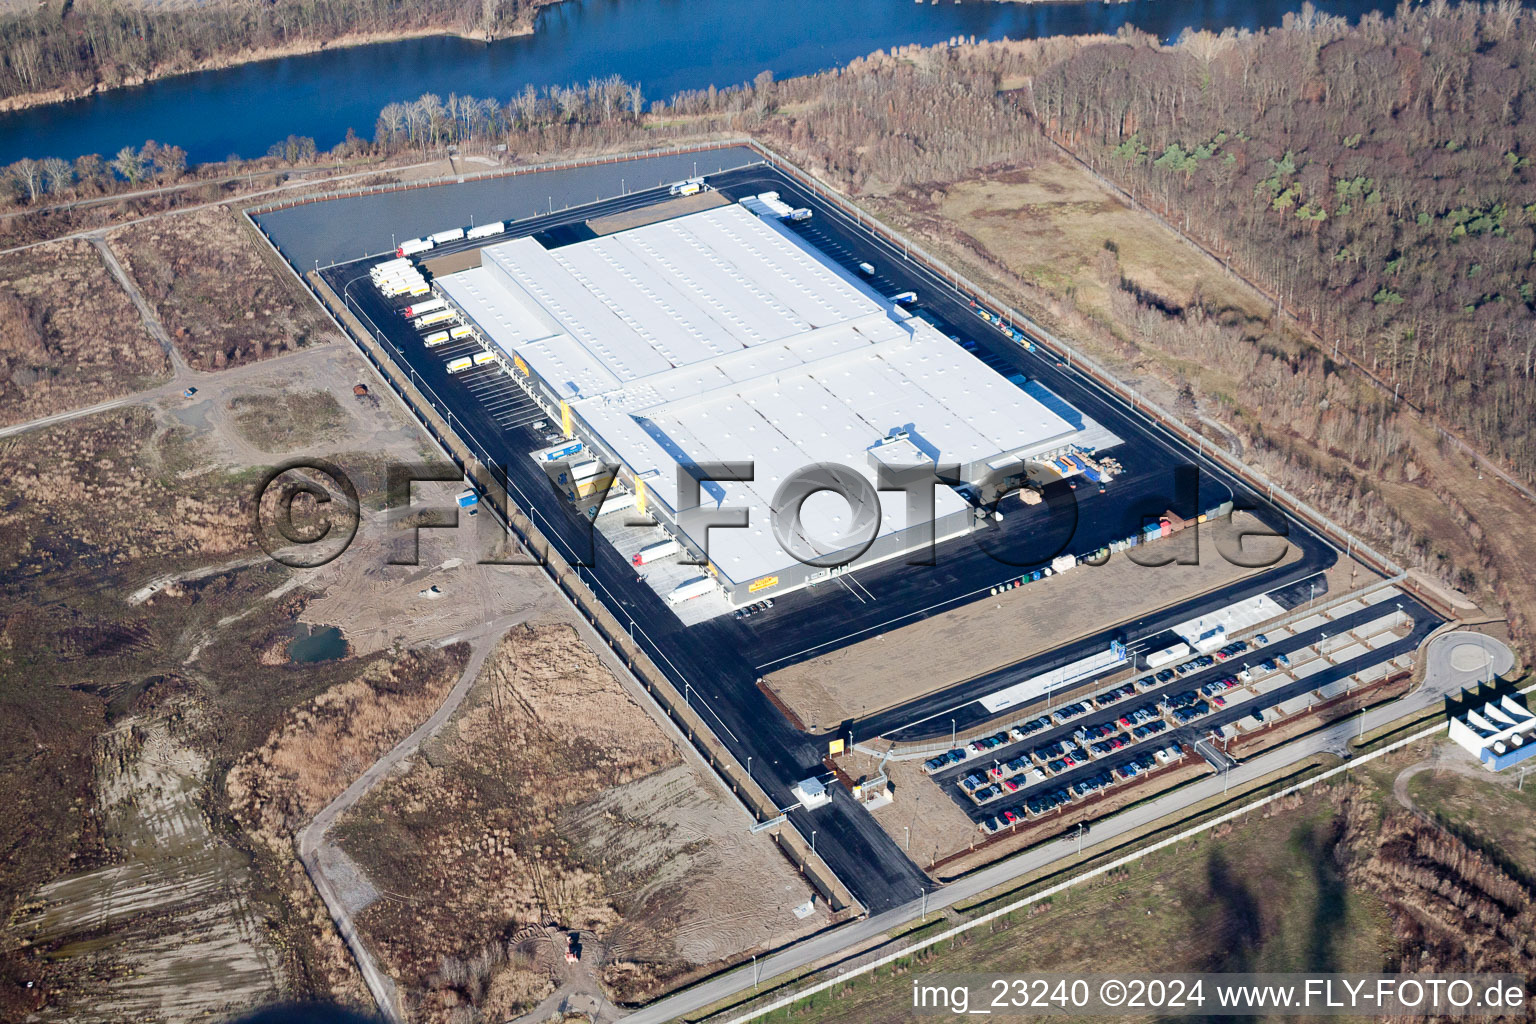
[{"xmin": 300, "ymin": 166, "xmax": 1406, "ymax": 910}]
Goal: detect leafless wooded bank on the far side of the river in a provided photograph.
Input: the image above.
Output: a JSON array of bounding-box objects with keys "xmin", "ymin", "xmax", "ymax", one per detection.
[{"xmin": 0, "ymin": 0, "xmax": 553, "ymax": 97}]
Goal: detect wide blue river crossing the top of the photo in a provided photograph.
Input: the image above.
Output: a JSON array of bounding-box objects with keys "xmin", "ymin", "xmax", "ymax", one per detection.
[{"xmin": 0, "ymin": 0, "xmax": 1395, "ymax": 164}]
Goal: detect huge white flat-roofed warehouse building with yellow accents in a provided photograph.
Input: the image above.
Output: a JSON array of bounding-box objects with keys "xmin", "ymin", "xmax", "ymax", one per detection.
[{"xmin": 438, "ymin": 196, "xmax": 1084, "ymax": 605}]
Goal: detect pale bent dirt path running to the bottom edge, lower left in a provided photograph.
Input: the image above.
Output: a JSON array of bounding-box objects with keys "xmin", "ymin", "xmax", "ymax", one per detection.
[{"xmin": 298, "ymin": 614, "xmax": 527, "ymax": 1024}]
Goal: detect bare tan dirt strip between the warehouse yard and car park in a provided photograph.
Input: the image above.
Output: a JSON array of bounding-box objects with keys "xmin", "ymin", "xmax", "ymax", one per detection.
[{"xmin": 766, "ymin": 513, "xmax": 1301, "ymax": 731}]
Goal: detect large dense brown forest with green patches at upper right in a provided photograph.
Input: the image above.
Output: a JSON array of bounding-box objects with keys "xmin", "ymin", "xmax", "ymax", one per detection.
[{"xmin": 1015, "ymin": 3, "xmax": 1536, "ymax": 479}]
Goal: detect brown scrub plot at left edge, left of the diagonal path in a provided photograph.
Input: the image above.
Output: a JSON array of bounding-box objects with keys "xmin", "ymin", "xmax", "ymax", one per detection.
[{"xmin": 0, "ymin": 239, "xmax": 170, "ymax": 424}]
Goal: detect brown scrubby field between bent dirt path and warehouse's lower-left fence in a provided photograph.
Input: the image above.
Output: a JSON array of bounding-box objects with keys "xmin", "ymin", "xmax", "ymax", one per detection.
[{"xmin": 336, "ymin": 623, "xmax": 826, "ymax": 1021}]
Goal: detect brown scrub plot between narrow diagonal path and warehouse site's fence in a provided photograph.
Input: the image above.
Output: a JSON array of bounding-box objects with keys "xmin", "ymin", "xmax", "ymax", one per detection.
[{"xmin": 109, "ymin": 207, "xmax": 336, "ymax": 370}]
